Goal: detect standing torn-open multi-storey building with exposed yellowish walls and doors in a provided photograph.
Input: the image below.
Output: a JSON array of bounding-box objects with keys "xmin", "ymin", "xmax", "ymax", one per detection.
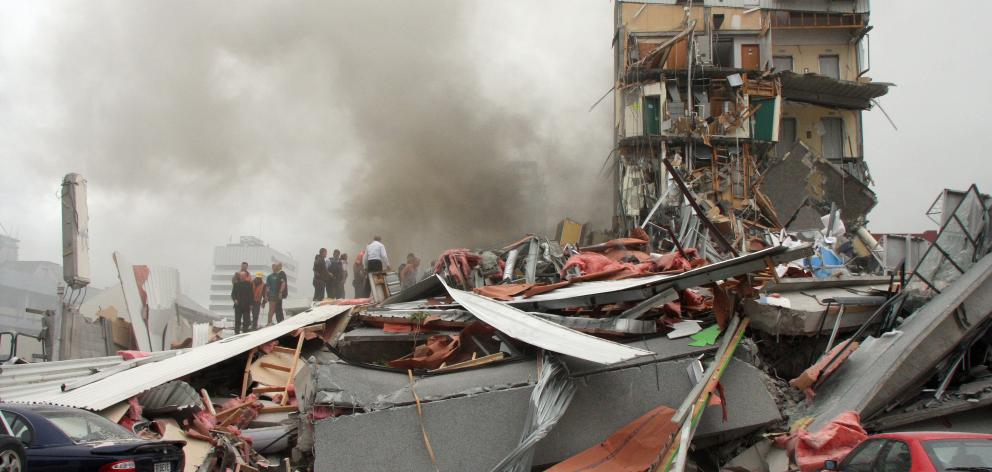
[{"xmin": 613, "ymin": 0, "xmax": 890, "ymax": 256}]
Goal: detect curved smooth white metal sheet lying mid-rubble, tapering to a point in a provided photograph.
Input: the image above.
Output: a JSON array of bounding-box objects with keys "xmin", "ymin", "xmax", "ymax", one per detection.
[{"xmin": 448, "ymin": 280, "xmax": 653, "ymax": 365}]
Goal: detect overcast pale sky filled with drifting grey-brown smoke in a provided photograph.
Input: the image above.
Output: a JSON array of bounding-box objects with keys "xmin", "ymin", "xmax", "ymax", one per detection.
[{"xmin": 0, "ymin": 0, "xmax": 992, "ymax": 302}]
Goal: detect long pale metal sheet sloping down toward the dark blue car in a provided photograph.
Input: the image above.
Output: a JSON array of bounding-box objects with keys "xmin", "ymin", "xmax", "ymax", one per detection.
[{"xmin": 2, "ymin": 305, "xmax": 352, "ymax": 411}]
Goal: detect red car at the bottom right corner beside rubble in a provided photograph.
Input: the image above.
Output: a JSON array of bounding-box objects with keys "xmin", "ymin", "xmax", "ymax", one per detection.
[{"xmin": 826, "ymin": 432, "xmax": 992, "ymax": 472}]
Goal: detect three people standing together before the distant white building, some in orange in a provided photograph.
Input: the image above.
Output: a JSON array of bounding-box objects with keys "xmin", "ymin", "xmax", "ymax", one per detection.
[{"xmin": 231, "ymin": 262, "xmax": 289, "ymax": 334}]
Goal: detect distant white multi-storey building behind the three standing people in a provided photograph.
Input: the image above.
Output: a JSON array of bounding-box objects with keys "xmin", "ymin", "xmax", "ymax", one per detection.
[{"xmin": 209, "ymin": 236, "xmax": 299, "ymax": 320}]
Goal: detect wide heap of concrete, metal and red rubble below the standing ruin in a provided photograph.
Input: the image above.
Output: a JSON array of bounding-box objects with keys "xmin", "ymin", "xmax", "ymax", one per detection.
[{"xmin": 0, "ymin": 186, "xmax": 992, "ymax": 471}]
